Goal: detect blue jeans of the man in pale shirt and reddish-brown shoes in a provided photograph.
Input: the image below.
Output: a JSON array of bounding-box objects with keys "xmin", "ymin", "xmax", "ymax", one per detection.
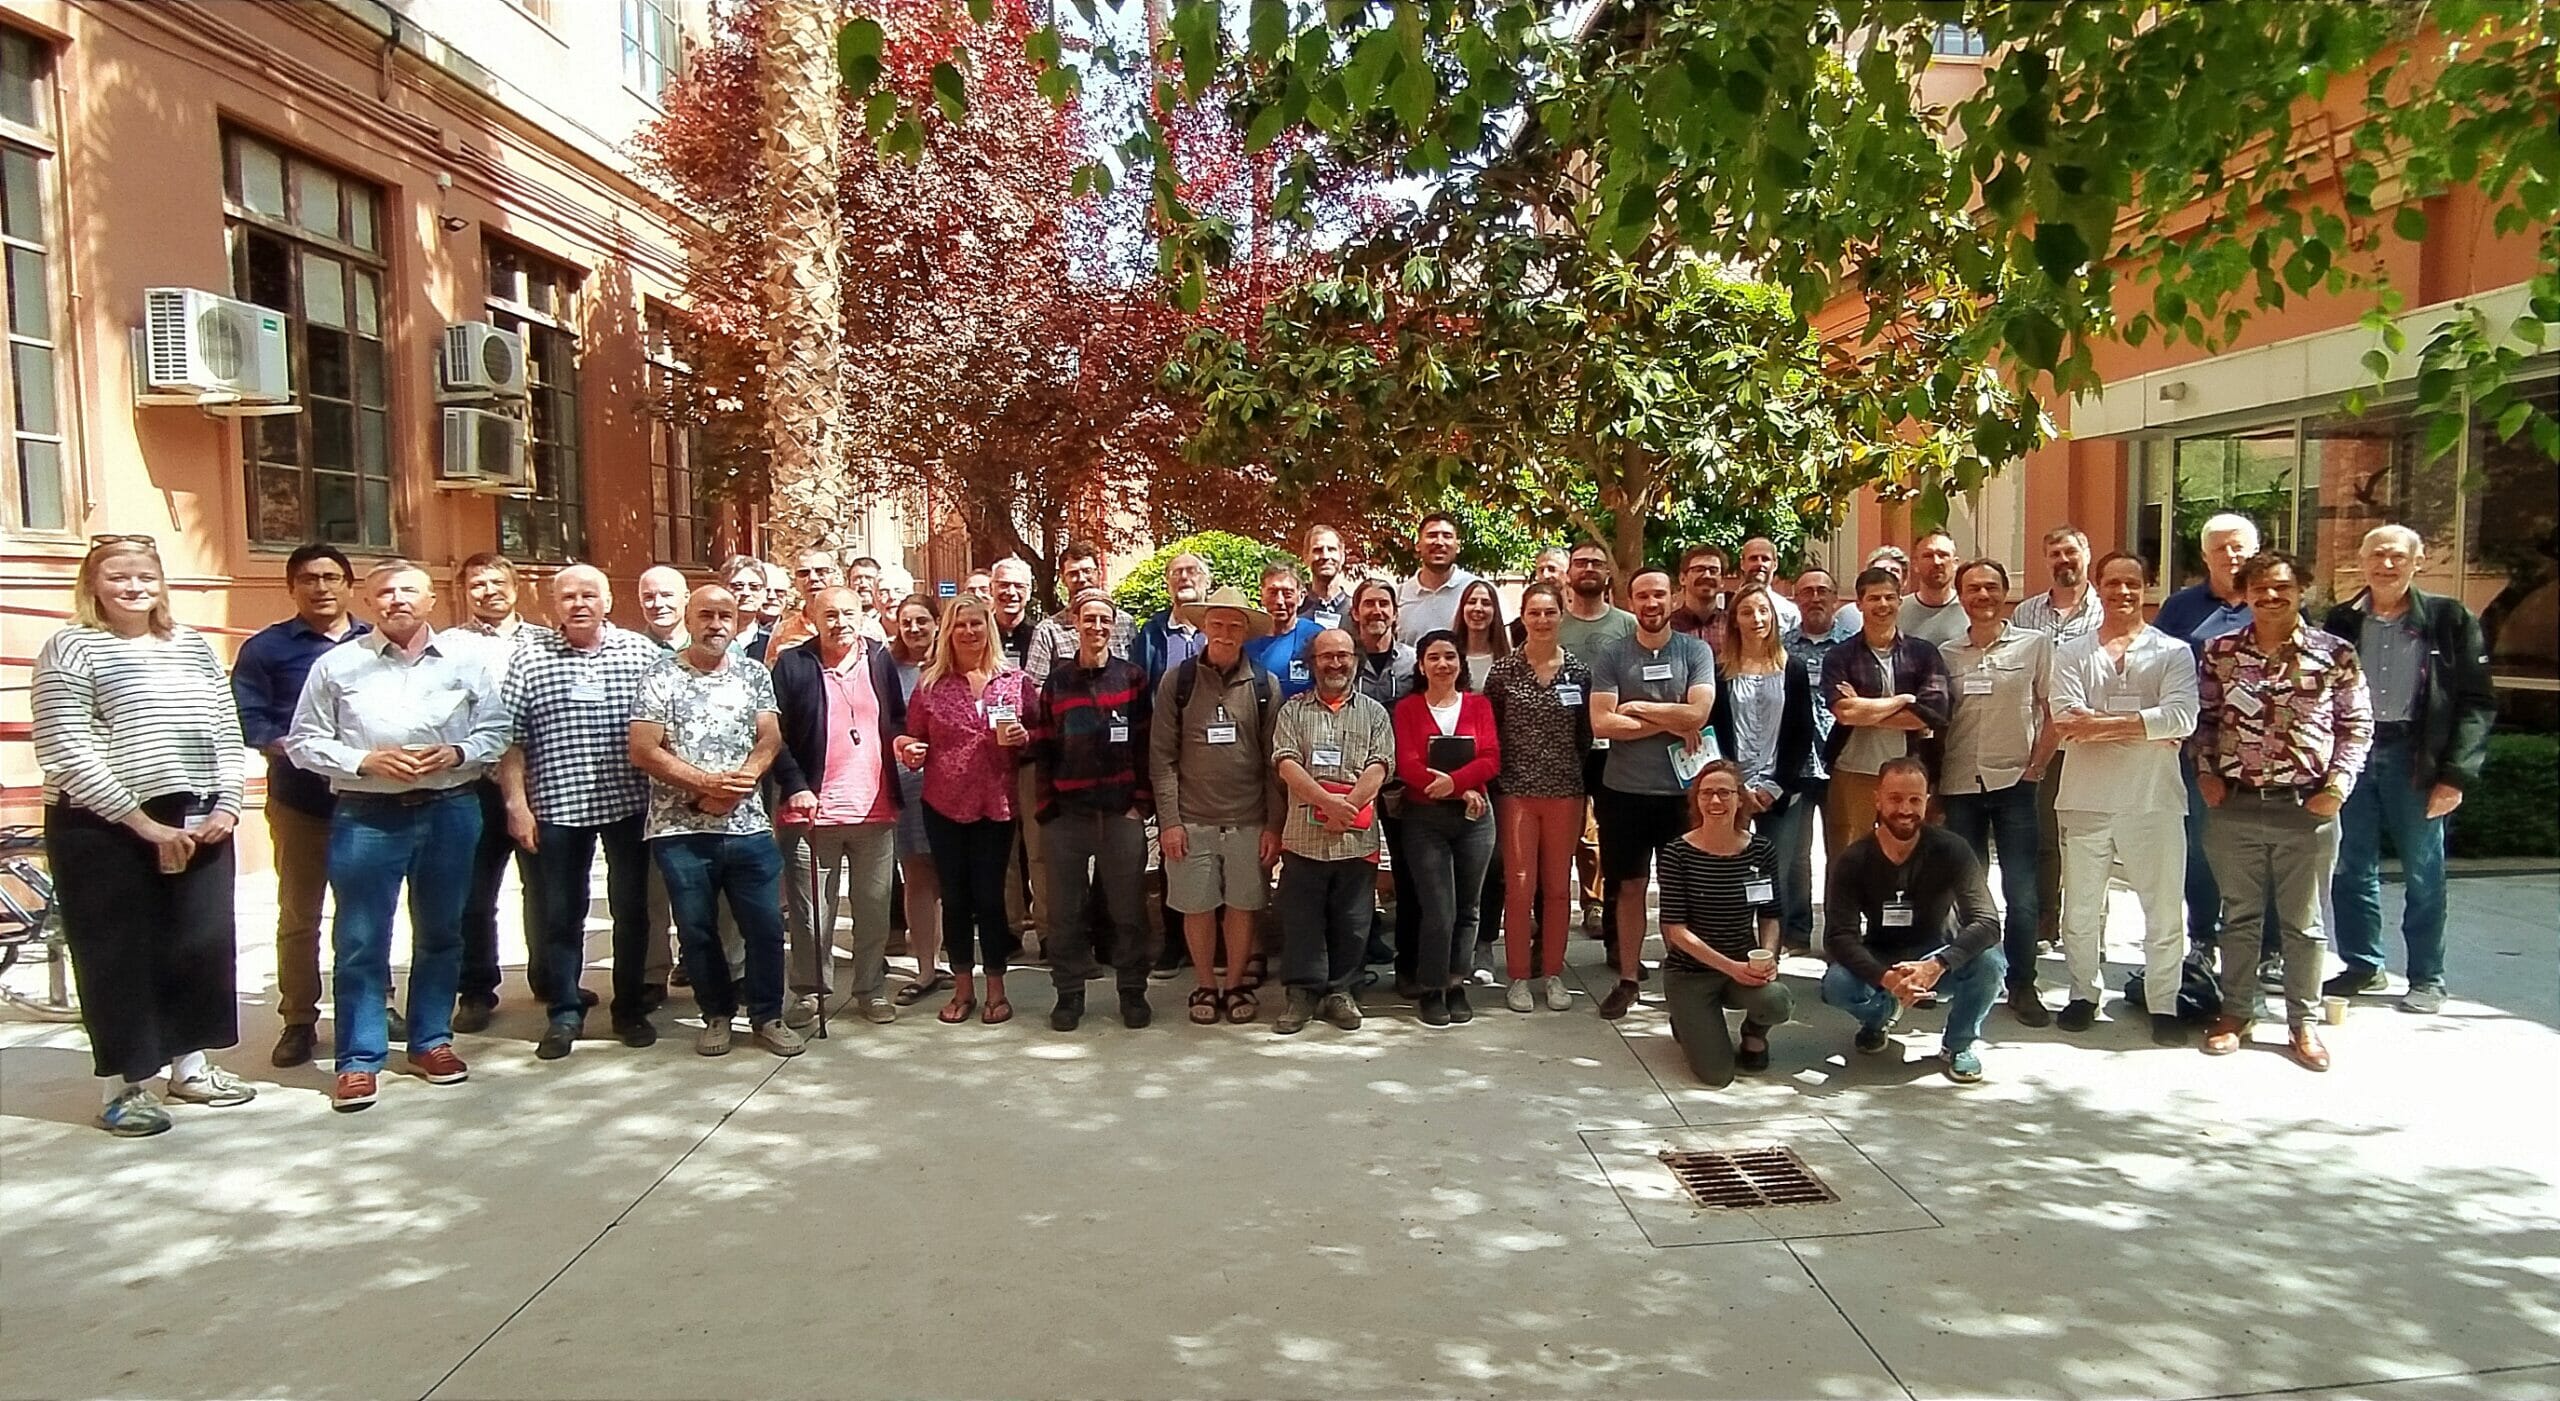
[{"xmin": 328, "ymin": 784, "xmax": 479, "ymax": 1073}]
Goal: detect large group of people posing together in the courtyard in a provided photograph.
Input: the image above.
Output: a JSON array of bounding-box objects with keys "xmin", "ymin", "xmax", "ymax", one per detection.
[{"xmin": 33, "ymin": 515, "xmax": 2493, "ymax": 1135}]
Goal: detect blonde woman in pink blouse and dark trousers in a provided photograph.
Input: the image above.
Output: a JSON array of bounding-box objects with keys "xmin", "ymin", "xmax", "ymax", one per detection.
[{"xmin": 899, "ymin": 594, "xmax": 1029, "ymax": 1027}]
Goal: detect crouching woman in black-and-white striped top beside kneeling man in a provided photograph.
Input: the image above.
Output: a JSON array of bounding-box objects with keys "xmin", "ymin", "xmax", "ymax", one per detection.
[{"xmin": 1656, "ymin": 758, "xmax": 1795, "ymax": 1089}]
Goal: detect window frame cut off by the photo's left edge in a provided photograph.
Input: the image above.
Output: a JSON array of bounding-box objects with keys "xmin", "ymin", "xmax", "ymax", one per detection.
[{"xmin": 0, "ymin": 26, "xmax": 75, "ymax": 540}]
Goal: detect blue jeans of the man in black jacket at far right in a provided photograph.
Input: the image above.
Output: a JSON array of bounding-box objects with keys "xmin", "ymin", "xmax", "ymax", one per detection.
[{"xmin": 2330, "ymin": 743, "xmax": 2445, "ymax": 989}]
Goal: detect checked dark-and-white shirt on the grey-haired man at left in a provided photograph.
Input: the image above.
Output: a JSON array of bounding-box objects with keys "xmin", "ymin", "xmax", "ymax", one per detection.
[{"xmin": 507, "ymin": 622, "xmax": 666, "ymax": 827}]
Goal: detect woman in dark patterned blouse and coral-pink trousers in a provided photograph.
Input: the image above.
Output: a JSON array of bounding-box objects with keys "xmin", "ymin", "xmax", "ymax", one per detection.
[{"xmin": 1485, "ymin": 584, "xmax": 1592, "ymax": 1012}]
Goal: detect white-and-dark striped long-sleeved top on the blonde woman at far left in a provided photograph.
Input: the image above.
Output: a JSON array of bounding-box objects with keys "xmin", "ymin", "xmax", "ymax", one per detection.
[{"xmin": 33, "ymin": 622, "xmax": 243, "ymax": 822}]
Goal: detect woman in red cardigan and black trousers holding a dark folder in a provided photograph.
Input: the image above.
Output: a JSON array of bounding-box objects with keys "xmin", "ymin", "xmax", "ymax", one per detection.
[{"xmin": 1395, "ymin": 630, "xmax": 1503, "ymax": 1027}]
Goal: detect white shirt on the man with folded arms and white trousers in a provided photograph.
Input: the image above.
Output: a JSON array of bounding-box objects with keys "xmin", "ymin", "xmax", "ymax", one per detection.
[{"xmin": 2045, "ymin": 622, "xmax": 2196, "ymax": 814}]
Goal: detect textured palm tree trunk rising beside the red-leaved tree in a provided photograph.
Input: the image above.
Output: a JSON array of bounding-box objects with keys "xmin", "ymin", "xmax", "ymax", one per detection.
[{"xmin": 760, "ymin": 0, "xmax": 852, "ymax": 558}]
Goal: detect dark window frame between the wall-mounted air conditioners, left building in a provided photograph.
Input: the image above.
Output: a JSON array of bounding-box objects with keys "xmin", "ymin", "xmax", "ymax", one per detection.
[{"xmin": 220, "ymin": 120, "xmax": 402, "ymax": 553}]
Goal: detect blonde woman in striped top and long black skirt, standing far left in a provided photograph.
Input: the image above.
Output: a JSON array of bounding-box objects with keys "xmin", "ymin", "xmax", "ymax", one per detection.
[{"xmin": 33, "ymin": 535, "xmax": 256, "ymax": 1137}]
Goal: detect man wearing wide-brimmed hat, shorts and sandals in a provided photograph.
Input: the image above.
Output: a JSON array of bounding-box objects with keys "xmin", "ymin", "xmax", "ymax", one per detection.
[{"xmin": 1147, "ymin": 587, "xmax": 1280, "ymax": 1024}]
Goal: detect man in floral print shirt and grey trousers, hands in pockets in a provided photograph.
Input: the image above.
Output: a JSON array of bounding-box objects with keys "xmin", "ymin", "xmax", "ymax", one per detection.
[{"xmin": 2196, "ymin": 551, "xmax": 2373, "ymax": 1071}]
